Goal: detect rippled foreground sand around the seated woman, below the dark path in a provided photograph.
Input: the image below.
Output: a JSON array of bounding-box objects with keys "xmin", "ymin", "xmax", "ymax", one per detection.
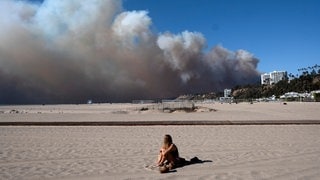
[{"xmin": 0, "ymin": 125, "xmax": 320, "ymax": 179}]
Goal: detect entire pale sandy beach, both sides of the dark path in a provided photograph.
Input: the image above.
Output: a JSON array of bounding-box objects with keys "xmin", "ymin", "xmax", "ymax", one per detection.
[{"xmin": 0, "ymin": 103, "xmax": 320, "ymax": 180}]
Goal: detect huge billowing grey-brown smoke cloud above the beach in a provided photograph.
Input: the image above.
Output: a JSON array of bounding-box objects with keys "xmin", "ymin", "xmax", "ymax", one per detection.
[{"xmin": 0, "ymin": 0, "xmax": 259, "ymax": 104}]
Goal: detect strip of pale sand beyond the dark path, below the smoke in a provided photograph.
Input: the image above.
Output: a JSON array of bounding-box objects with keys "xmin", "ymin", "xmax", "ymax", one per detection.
[{"xmin": 0, "ymin": 102, "xmax": 320, "ymax": 122}]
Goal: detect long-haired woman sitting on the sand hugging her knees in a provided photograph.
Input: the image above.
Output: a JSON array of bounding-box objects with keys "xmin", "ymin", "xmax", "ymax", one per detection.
[{"xmin": 157, "ymin": 134, "xmax": 183, "ymax": 169}]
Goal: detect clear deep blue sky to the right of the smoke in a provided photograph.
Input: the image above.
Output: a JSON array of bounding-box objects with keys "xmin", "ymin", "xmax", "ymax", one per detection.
[{"xmin": 123, "ymin": 0, "xmax": 320, "ymax": 74}]
